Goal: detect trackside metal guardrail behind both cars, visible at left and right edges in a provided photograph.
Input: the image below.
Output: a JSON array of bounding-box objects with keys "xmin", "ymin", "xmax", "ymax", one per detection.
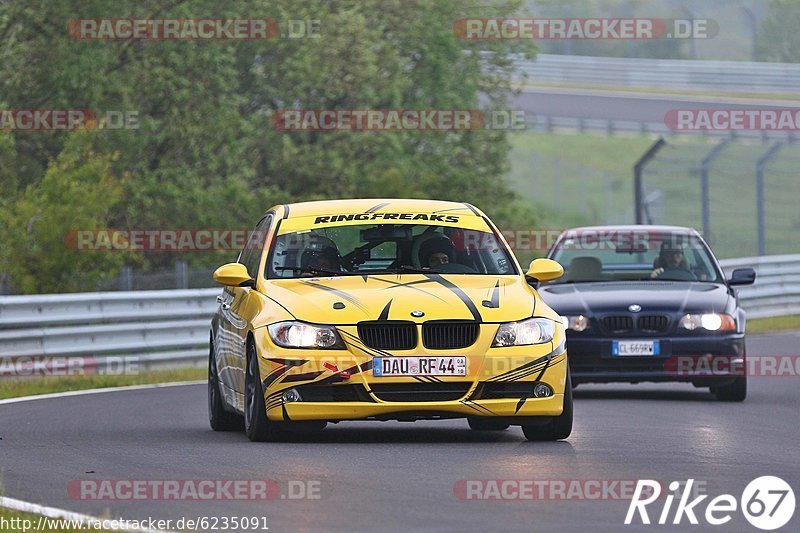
[{"xmin": 0, "ymin": 255, "xmax": 800, "ymax": 377}]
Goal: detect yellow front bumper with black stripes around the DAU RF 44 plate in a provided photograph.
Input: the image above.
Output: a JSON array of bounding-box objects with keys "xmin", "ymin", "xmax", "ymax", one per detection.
[{"xmin": 257, "ymin": 324, "xmax": 567, "ymax": 421}]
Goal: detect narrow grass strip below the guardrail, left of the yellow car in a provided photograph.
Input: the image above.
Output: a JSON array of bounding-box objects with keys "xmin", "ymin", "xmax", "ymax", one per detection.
[{"xmin": 0, "ymin": 367, "xmax": 207, "ymax": 399}]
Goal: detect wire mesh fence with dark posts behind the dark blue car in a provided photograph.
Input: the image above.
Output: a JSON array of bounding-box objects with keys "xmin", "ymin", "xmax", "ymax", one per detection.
[{"xmin": 638, "ymin": 138, "xmax": 800, "ymax": 257}]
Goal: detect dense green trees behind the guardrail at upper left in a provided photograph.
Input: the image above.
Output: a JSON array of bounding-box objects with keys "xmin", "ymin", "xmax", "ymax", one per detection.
[{"xmin": 0, "ymin": 0, "xmax": 534, "ymax": 290}]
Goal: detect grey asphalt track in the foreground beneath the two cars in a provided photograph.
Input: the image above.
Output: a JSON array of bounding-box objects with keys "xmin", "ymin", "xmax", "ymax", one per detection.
[{"xmin": 0, "ymin": 333, "xmax": 800, "ymax": 532}]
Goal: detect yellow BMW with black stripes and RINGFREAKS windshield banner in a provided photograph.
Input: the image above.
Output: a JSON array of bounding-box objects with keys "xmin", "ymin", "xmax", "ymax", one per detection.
[{"xmin": 208, "ymin": 199, "xmax": 572, "ymax": 441}]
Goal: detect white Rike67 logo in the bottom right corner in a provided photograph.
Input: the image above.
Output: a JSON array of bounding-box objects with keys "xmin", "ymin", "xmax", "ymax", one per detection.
[{"xmin": 625, "ymin": 476, "xmax": 795, "ymax": 531}]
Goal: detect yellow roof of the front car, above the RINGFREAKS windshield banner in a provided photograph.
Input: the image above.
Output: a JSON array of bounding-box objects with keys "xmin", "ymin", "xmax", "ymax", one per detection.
[{"xmin": 283, "ymin": 198, "xmax": 483, "ymax": 218}]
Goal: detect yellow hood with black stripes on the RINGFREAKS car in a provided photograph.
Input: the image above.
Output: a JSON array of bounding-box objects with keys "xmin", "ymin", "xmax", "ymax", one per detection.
[{"xmin": 264, "ymin": 274, "xmax": 537, "ymax": 324}]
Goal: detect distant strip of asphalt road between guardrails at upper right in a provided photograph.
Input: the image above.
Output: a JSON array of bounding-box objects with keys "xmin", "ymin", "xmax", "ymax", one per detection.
[{"xmin": 510, "ymin": 88, "xmax": 798, "ymax": 124}]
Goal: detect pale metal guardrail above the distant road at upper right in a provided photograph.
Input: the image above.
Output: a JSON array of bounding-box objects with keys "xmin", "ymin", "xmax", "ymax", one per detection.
[{"xmin": 515, "ymin": 54, "xmax": 800, "ymax": 94}]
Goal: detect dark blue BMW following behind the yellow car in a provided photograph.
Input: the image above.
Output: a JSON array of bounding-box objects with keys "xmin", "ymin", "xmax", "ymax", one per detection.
[{"xmin": 538, "ymin": 226, "xmax": 755, "ymax": 401}]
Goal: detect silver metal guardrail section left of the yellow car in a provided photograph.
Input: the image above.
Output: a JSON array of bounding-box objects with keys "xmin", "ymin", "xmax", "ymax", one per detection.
[{"xmin": 0, "ymin": 288, "xmax": 220, "ymax": 377}]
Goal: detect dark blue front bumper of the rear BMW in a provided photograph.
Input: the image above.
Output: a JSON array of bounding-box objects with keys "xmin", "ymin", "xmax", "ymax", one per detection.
[{"xmin": 567, "ymin": 333, "xmax": 745, "ymax": 386}]
